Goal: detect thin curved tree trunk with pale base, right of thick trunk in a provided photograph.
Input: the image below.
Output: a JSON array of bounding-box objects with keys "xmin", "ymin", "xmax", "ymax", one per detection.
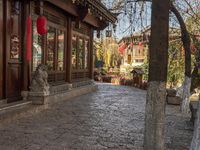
[{"xmin": 170, "ymin": 3, "xmax": 191, "ymax": 113}]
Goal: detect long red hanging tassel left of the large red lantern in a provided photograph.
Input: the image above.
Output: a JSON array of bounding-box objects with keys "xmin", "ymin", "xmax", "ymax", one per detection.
[{"xmin": 26, "ymin": 16, "xmax": 32, "ymax": 61}]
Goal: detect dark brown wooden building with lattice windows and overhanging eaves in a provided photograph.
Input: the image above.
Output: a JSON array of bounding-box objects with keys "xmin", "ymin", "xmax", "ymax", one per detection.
[{"xmin": 0, "ymin": 0, "xmax": 116, "ymax": 103}]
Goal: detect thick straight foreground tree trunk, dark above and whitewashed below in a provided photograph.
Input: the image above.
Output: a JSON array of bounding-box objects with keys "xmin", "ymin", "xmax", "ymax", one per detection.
[{"xmin": 144, "ymin": 0, "xmax": 170, "ymax": 150}]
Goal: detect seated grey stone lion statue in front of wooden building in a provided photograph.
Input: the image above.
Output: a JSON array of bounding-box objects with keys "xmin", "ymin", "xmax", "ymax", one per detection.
[{"xmin": 30, "ymin": 64, "xmax": 49, "ymax": 95}]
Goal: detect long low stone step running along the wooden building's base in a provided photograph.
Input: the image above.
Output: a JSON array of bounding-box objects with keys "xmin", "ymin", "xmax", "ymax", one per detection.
[{"xmin": 0, "ymin": 85, "xmax": 97, "ymax": 125}]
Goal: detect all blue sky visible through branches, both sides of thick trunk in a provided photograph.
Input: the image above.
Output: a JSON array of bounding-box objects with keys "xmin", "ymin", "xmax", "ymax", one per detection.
[{"xmin": 100, "ymin": 0, "xmax": 200, "ymax": 40}]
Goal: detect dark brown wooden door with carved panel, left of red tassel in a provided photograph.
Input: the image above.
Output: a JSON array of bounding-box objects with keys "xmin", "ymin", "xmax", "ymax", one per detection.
[{"xmin": 6, "ymin": 0, "xmax": 22, "ymax": 102}]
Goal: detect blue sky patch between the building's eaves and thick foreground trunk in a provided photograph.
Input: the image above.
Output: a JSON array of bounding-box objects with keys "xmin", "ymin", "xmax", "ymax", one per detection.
[{"xmin": 101, "ymin": 0, "xmax": 151, "ymax": 40}]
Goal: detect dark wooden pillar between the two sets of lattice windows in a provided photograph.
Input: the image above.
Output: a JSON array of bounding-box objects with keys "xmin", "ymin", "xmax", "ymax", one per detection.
[{"xmin": 65, "ymin": 18, "xmax": 72, "ymax": 83}]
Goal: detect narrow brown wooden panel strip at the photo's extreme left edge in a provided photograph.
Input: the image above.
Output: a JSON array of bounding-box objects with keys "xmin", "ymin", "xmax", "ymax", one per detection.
[{"xmin": 0, "ymin": 0, "xmax": 3, "ymax": 99}]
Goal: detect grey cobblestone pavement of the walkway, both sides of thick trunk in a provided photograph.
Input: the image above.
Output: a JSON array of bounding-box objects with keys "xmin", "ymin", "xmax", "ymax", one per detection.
[{"xmin": 0, "ymin": 84, "xmax": 192, "ymax": 150}]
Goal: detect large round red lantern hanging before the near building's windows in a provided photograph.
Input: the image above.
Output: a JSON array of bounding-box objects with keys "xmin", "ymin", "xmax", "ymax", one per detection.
[{"xmin": 37, "ymin": 16, "xmax": 47, "ymax": 35}]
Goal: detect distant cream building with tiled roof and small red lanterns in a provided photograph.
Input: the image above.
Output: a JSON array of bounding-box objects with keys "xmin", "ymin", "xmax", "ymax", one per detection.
[{"xmin": 118, "ymin": 28, "xmax": 150, "ymax": 72}]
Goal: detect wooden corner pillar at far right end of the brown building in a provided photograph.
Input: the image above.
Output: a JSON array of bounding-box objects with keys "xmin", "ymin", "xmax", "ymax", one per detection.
[{"xmin": 90, "ymin": 29, "xmax": 94, "ymax": 79}]
